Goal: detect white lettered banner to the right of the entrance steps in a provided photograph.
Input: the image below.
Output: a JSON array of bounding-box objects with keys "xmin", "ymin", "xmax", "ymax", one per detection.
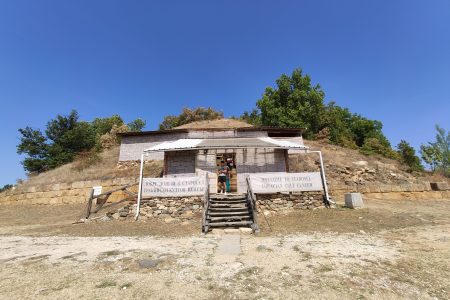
[{"xmin": 249, "ymin": 172, "xmax": 323, "ymax": 194}]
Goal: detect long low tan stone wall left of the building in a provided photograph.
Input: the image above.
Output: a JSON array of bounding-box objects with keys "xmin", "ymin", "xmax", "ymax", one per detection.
[{"xmin": 0, "ymin": 177, "xmax": 139, "ymax": 205}]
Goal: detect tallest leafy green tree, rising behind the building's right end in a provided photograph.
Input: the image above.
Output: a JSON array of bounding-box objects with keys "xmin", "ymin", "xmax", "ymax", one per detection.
[{"xmin": 256, "ymin": 68, "xmax": 325, "ymax": 138}]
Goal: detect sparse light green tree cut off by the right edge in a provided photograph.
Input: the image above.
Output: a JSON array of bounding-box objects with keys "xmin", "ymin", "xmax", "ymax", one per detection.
[{"xmin": 420, "ymin": 125, "xmax": 450, "ymax": 177}]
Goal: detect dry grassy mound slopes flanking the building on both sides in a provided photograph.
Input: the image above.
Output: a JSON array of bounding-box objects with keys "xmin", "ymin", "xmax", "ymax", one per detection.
[{"xmin": 10, "ymin": 140, "xmax": 445, "ymax": 195}]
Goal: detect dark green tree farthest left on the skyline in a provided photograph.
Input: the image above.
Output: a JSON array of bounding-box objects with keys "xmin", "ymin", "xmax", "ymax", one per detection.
[{"xmin": 17, "ymin": 126, "xmax": 49, "ymax": 172}]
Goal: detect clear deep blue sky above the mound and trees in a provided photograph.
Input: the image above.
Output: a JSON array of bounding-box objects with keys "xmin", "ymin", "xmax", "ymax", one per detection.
[{"xmin": 0, "ymin": 0, "xmax": 450, "ymax": 185}]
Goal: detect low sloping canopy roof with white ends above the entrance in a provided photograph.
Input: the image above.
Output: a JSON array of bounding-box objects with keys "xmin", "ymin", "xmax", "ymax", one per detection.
[{"xmin": 144, "ymin": 137, "xmax": 309, "ymax": 153}]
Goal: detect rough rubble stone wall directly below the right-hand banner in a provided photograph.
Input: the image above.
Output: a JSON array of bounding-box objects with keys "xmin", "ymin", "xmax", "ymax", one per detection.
[{"xmin": 256, "ymin": 192, "xmax": 325, "ymax": 213}]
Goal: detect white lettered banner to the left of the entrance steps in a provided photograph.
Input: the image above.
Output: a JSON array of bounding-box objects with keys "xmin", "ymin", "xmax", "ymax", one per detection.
[{"xmin": 142, "ymin": 176, "xmax": 206, "ymax": 197}]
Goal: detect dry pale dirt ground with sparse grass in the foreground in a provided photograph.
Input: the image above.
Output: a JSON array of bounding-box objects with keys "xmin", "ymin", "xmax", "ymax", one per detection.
[{"xmin": 0, "ymin": 199, "xmax": 450, "ymax": 299}]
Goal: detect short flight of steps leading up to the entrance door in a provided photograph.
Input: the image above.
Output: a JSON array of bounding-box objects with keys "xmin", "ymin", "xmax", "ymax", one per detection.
[{"xmin": 205, "ymin": 194, "xmax": 254, "ymax": 232}]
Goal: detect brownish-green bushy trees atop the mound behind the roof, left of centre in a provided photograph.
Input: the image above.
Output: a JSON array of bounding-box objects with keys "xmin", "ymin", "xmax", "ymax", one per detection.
[{"xmin": 159, "ymin": 107, "xmax": 223, "ymax": 130}]
